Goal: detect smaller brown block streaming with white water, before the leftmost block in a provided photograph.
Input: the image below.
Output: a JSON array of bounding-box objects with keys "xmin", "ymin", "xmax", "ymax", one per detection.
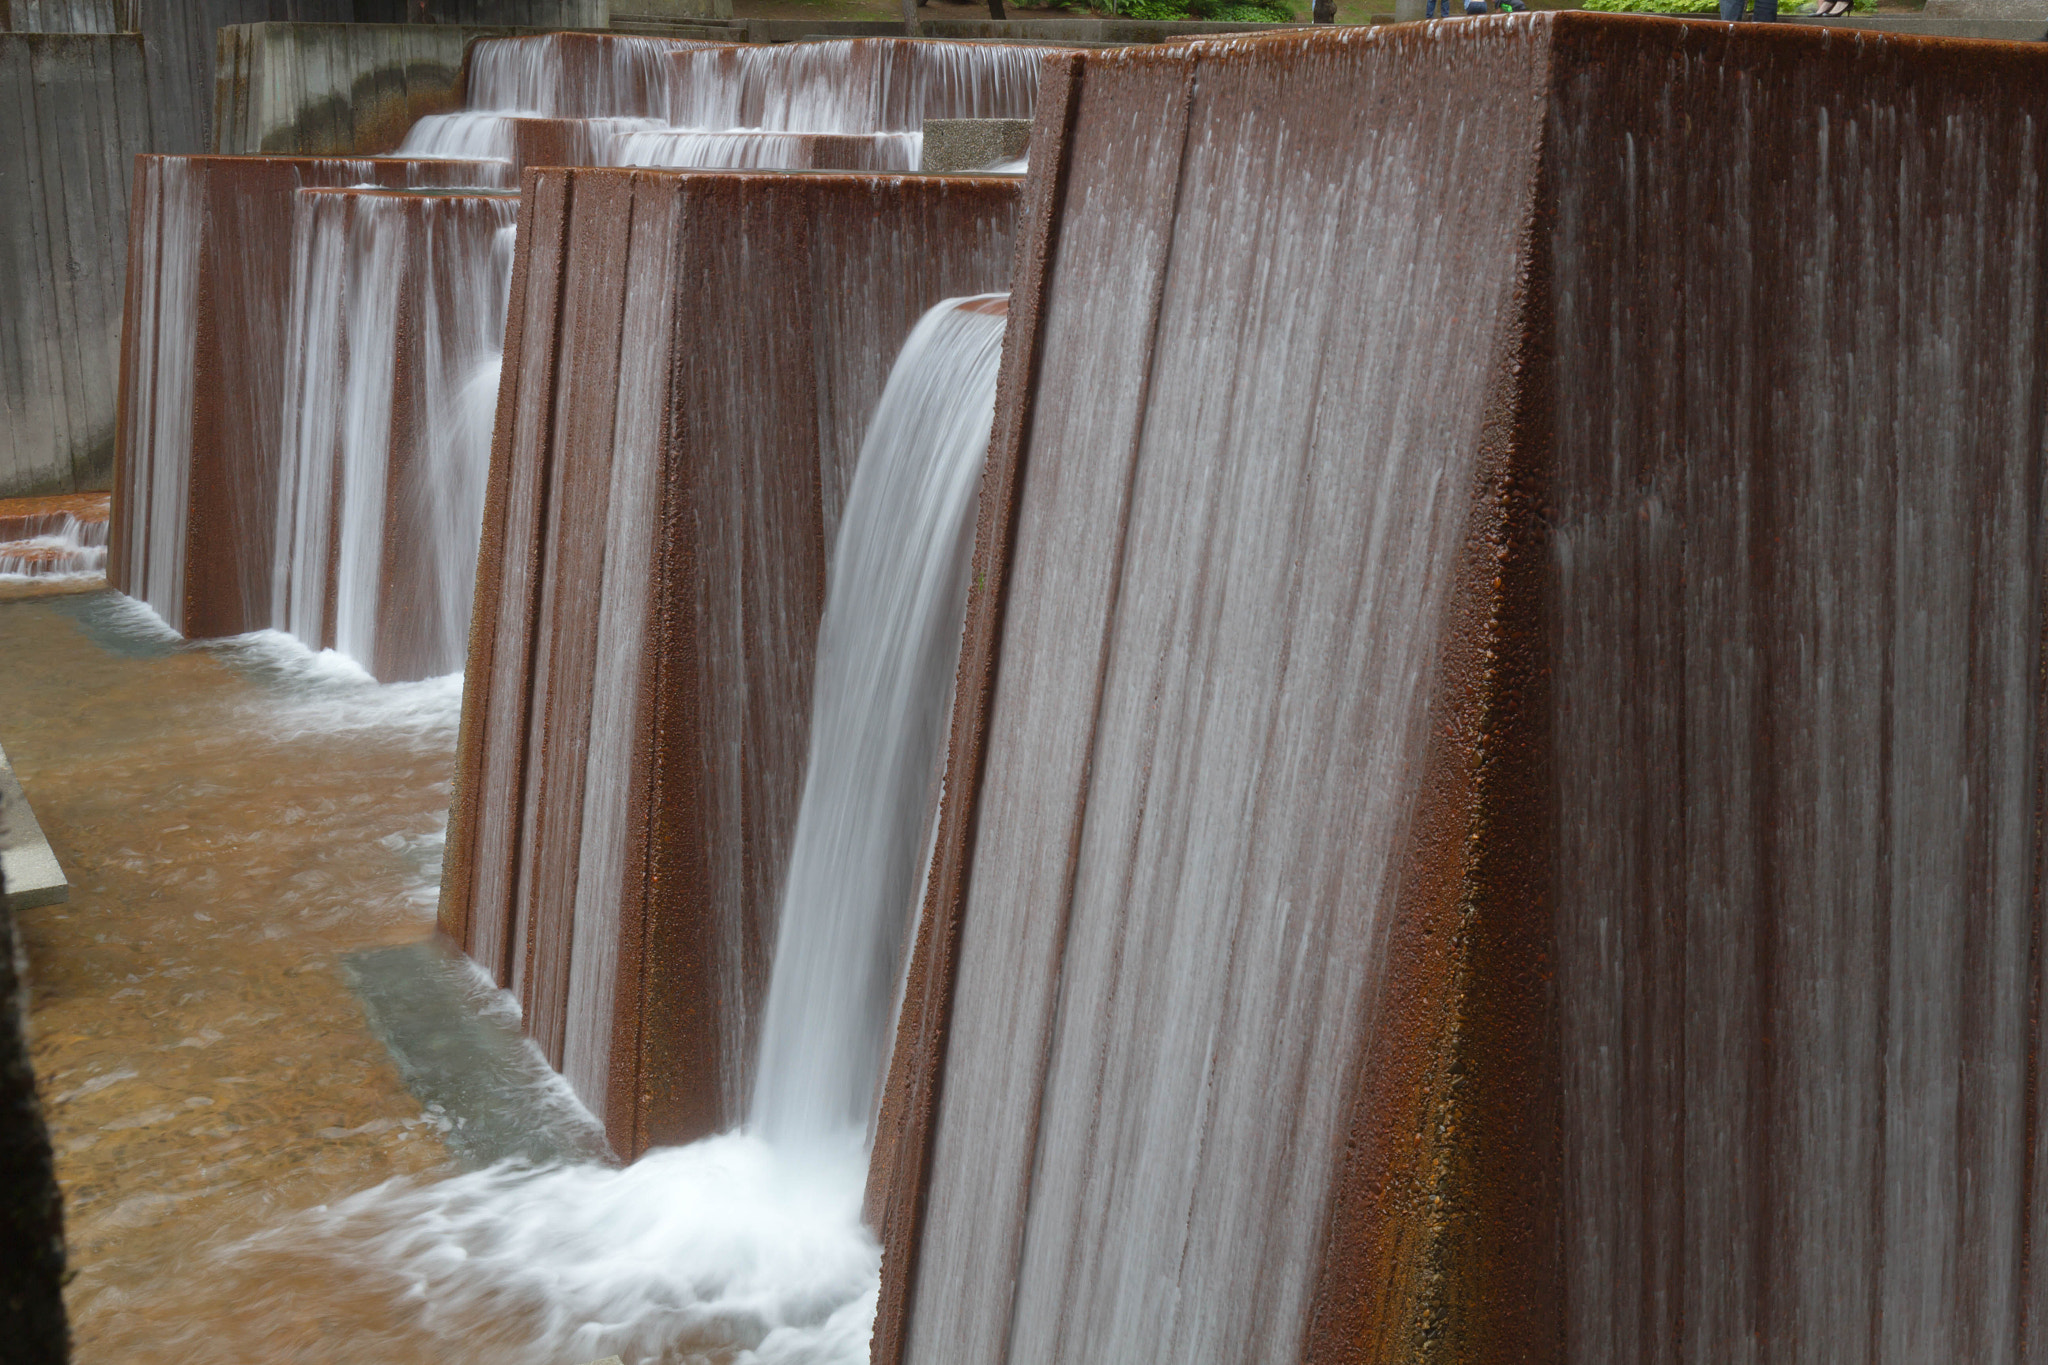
[{"xmin": 272, "ymin": 190, "xmax": 518, "ymax": 679}]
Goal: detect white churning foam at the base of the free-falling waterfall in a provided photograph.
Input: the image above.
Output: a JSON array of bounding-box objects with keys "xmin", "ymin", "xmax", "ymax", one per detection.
[{"xmin": 217, "ymin": 1134, "xmax": 881, "ymax": 1365}]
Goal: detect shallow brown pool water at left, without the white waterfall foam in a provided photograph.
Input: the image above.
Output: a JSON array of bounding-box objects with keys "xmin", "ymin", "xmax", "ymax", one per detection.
[{"xmin": 0, "ymin": 581, "xmax": 461, "ymax": 1365}]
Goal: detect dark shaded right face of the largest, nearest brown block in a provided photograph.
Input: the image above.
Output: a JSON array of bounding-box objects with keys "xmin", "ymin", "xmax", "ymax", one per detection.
[{"xmin": 1544, "ymin": 25, "xmax": 2048, "ymax": 1361}]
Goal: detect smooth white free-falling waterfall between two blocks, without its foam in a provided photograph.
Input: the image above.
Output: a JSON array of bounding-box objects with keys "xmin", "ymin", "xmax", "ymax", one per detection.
[{"xmin": 752, "ymin": 295, "xmax": 1006, "ymax": 1144}]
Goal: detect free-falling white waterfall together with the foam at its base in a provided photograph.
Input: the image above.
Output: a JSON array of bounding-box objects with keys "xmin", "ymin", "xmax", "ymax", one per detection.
[{"xmin": 176, "ymin": 295, "xmax": 1006, "ymax": 1365}]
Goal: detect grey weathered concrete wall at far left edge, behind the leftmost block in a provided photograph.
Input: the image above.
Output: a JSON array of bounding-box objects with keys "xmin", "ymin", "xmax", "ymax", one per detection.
[{"xmin": 0, "ymin": 33, "xmax": 152, "ymax": 497}]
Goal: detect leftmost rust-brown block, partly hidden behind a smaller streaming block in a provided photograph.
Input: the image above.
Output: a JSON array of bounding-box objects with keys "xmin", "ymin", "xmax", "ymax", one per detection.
[{"xmin": 106, "ymin": 156, "xmax": 502, "ymax": 639}]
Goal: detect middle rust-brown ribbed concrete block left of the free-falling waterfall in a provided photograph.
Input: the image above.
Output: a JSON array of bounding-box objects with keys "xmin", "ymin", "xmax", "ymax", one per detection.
[{"xmin": 440, "ymin": 170, "xmax": 1018, "ymax": 1156}]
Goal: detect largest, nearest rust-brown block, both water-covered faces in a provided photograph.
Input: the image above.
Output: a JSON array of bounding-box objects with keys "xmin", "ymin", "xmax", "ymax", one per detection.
[{"xmin": 870, "ymin": 14, "xmax": 2048, "ymax": 1365}]
